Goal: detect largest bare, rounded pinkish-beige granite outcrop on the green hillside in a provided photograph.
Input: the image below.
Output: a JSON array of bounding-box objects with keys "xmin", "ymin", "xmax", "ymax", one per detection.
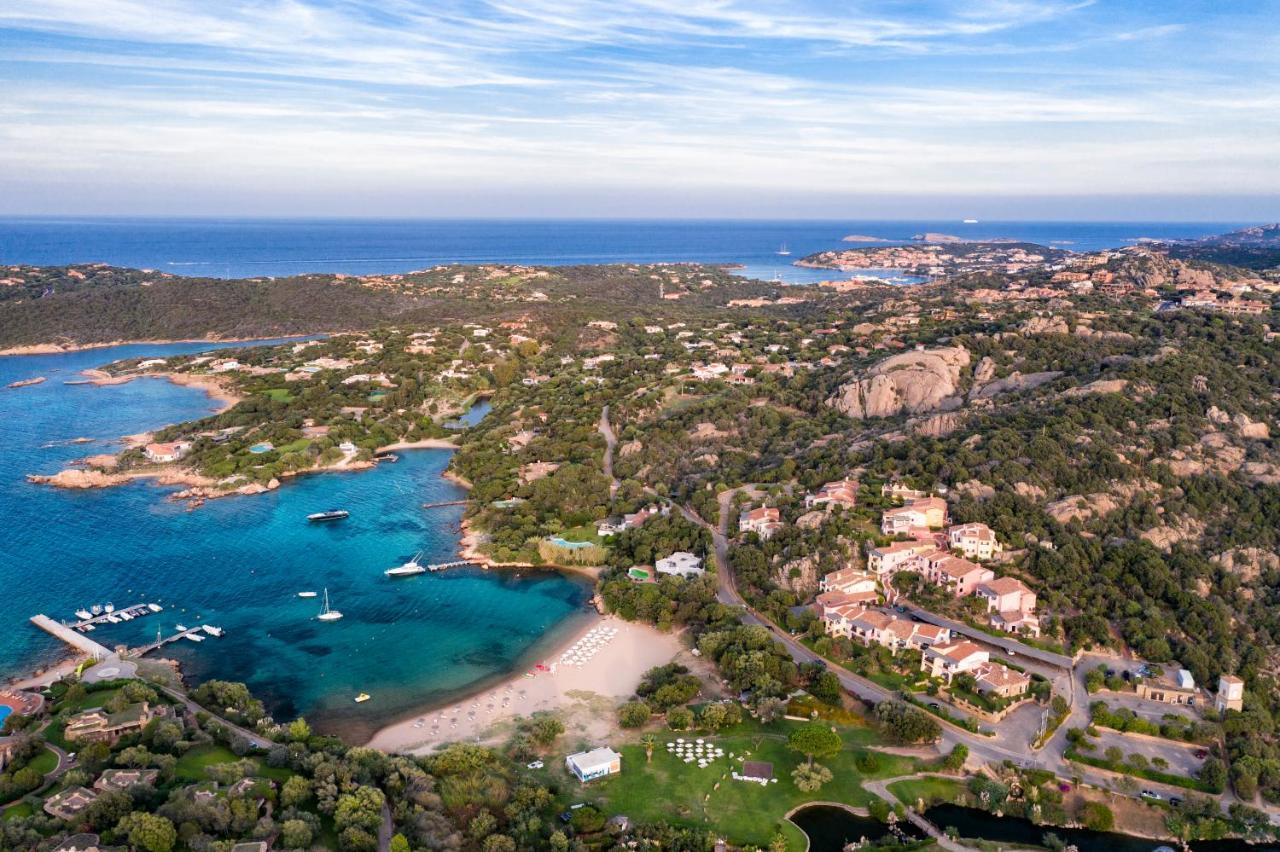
[{"xmin": 827, "ymin": 347, "xmax": 969, "ymax": 420}]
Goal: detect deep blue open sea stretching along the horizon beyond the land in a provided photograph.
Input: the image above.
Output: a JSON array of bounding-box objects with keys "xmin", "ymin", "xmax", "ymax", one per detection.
[{"xmin": 0, "ymin": 219, "xmax": 1256, "ymax": 284}]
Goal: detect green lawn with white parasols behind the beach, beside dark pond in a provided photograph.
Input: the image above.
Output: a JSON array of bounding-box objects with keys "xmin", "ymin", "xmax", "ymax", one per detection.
[{"xmin": 581, "ymin": 722, "xmax": 915, "ymax": 849}]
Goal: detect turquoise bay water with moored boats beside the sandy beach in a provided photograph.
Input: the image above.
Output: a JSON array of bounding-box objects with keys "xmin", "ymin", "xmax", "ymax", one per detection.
[{"xmin": 0, "ymin": 344, "xmax": 590, "ymax": 741}]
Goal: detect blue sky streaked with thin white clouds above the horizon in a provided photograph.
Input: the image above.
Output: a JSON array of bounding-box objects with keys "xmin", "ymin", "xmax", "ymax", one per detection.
[{"xmin": 0, "ymin": 0, "xmax": 1280, "ymax": 220}]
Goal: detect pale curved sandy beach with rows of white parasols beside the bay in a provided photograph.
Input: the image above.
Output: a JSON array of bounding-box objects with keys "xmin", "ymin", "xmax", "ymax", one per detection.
[{"xmin": 369, "ymin": 617, "xmax": 694, "ymax": 753}]
